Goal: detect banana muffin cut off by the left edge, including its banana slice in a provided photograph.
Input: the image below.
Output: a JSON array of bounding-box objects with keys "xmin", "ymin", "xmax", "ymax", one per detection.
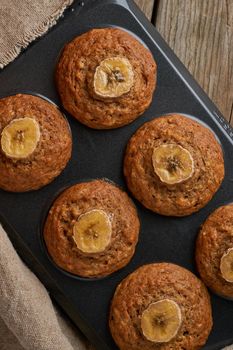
[{"xmin": 0, "ymin": 94, "xmax": 72, "ymax": 192}]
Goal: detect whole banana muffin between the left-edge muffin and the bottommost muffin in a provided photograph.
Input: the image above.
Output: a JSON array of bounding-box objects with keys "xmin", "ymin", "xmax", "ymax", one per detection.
[{"xmin": 44, "ymin": 180, "xmax": 140, "ymax": 278}]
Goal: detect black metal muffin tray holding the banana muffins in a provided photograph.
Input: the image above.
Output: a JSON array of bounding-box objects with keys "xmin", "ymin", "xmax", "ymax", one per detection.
[{"xmin": 0, "ymin": 0, "xmax": 233, "ymax": 350}]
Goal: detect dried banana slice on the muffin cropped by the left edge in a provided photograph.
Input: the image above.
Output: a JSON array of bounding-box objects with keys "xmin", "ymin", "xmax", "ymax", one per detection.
[{"xmin": 1, "ymin": 117, "xmax": 40, "ymax": 159}]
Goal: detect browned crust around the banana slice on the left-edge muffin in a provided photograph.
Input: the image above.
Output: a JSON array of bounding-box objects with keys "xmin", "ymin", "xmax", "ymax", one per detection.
[{"xmin": 0, "ymin": 94, "xmax": 72, "ymax": 192}]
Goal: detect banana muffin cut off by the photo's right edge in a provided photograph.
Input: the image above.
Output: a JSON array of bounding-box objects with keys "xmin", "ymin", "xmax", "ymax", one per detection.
[{"xmin": 196, "ymin": 204, "xmax": 233, "ymax": 299}]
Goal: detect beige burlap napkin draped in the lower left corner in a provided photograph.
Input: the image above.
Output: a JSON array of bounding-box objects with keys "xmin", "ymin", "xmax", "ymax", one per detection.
[{"xmin": 0, "ymin": 226, "xmax": 91, "ymax": 350}]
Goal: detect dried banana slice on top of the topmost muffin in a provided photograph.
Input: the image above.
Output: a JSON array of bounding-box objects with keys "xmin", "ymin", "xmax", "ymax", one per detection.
[{"xmin": 94, "ymin": 57, "xmax": 134, "ymax": 98}]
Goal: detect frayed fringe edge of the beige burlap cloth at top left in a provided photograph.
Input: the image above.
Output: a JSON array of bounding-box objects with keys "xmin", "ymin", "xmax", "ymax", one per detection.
[{"xmin": 0, "ymin": 0, "xmax": 74, "ymax": 69}]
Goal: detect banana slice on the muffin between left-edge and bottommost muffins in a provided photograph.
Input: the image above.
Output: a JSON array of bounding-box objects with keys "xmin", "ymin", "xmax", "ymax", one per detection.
[{"xmin": 73, "ymin": 209, "xmax": 112, "ymax": 253}]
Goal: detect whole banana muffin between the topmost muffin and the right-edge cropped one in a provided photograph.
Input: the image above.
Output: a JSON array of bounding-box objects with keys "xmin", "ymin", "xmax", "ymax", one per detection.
[{"xmin": 124, "ymin": 114, "xmax": 224, "ymax": 216}]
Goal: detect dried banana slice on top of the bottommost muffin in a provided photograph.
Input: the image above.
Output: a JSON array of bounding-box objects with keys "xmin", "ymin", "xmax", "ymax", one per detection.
[{"xmin": 141, "ymin": 299, "xmax": 182, "ymax": 343}]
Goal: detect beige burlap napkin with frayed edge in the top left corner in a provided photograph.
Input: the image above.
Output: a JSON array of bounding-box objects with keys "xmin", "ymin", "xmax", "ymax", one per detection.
[{"xmin": 0, "ymin": 0, "xmax": 73, "ymax": 68}]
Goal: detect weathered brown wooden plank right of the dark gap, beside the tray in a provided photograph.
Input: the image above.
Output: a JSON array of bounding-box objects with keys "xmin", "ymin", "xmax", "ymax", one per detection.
[{"xmin": 155, "ymin": 0, "xmax": 233, "ymax": 125}]
